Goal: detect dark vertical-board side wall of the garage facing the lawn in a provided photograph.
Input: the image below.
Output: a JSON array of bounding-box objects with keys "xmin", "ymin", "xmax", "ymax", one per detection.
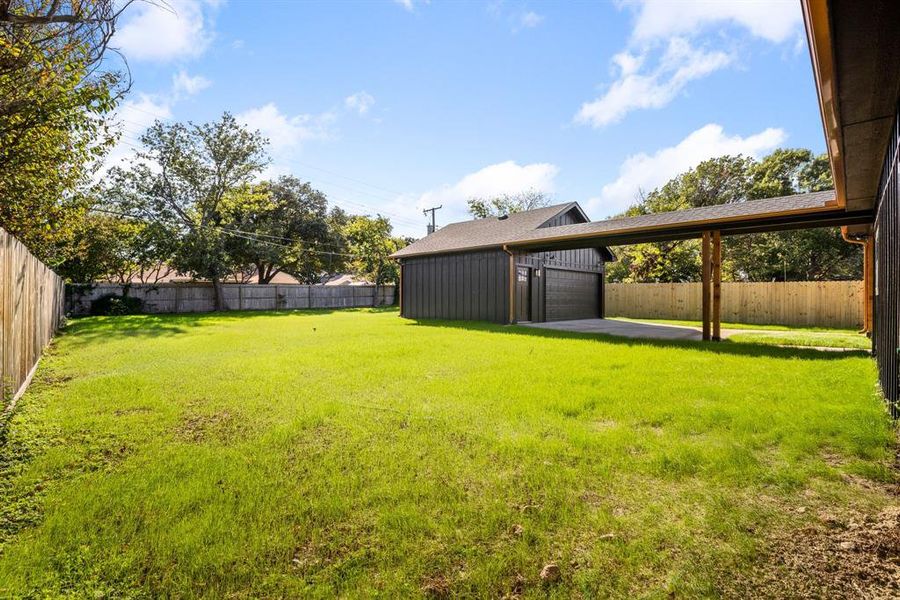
[{"xmin": 402, "ymin": 250, "xmax": 509, "ymax": 323}]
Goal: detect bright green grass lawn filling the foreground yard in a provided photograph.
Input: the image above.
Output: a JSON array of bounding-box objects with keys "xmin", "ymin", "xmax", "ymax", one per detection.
[{"xmin": 0, "ymin": 310, "xmax": 895, "ymax": 598}]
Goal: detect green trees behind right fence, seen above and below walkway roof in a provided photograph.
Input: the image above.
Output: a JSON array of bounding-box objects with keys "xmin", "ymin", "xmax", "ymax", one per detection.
[{"xmin": 607, "ymin": 149, "xmax": 862, "ymax": 282}]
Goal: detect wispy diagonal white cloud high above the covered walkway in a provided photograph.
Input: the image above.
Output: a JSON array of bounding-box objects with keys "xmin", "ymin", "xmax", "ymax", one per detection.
[{"xmin": 575, "ymin": 38, "xmax": 732, "ymax": 127}]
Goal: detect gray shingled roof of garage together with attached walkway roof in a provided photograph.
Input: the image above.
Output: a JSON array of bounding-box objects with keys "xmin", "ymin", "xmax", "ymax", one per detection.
[{"xmin": 393, "ymin": 190, "xmax": 865, "ymax": 258}]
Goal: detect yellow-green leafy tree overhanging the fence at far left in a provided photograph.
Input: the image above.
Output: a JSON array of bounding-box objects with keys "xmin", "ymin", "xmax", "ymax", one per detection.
[{"xmin": 0, "ymin": 0, "xmax": 130, "ymax": 265}]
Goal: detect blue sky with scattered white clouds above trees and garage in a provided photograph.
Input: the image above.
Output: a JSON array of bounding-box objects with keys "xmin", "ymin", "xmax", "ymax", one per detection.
[{"xmin": 110, "ymin": 0, "xmax": 824, "ymax": 236}]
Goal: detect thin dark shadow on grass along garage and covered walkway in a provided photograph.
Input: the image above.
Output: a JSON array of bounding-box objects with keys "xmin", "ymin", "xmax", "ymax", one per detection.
[{"xmin": 408, "ymin": 319, "xmax": 869, "ymax": 360}]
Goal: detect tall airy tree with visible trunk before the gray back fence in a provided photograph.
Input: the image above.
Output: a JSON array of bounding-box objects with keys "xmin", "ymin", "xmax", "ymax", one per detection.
[{"xmin": 108, "ymin": 113, "xmax": 268, "ymax": 310}]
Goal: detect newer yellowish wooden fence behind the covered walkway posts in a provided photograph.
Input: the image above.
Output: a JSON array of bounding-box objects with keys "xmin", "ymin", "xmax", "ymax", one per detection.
[{"xmin": 606, "ymin": 281, "xmax": 864, "ymax": 328}]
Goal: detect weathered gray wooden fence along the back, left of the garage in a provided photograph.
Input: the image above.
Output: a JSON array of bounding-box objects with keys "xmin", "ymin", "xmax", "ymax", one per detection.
[{"xmin": 66, "ymin": 283, "xmax": 394, "ymax": 315}]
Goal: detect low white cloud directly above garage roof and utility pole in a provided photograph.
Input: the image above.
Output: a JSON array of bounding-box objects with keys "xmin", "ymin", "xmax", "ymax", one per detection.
[{"xmin": 407, "ymin": 160, "xmax": 559, "ymax": 223}]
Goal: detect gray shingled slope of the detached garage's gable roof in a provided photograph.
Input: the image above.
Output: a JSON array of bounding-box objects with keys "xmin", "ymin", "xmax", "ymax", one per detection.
[{"xmin": 391, "ymin": 202, "xmax": 587, "ymax": 258}]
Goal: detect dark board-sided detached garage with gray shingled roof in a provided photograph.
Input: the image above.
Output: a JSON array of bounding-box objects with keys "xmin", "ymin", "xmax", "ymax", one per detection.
[{"xmin": 393, "ymin": 202, "xmax": 614, "ymax": 323}]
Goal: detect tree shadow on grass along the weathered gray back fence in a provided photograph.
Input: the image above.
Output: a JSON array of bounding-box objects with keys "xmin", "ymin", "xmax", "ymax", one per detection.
[{"xmin": 60, "ymin": 306, "xmax": 398, "ymax": 346}]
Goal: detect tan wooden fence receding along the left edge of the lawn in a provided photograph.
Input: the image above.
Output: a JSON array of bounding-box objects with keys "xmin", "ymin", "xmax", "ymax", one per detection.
[{"xmin": 0, "ymin": 229, "xmax": 64, "ymax": 411}]
